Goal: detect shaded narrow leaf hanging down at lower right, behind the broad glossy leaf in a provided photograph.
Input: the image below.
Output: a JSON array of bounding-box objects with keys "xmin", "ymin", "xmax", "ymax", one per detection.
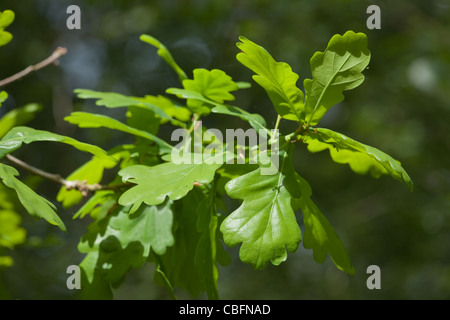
[{"xmin": 294, "ymin": 174, "xmax": 355, "ymax": 274}]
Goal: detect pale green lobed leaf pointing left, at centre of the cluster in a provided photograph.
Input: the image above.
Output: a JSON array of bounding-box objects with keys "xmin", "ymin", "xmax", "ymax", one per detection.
[{"xmin": 119, "ymin": 155, "xmax": 222, "ymax": 213}]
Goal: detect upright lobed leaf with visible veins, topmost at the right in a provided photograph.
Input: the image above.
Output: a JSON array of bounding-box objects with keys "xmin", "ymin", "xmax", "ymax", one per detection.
[{"xmin": 304, "ymin": 31, "xmax": 370, "ymax": 126}]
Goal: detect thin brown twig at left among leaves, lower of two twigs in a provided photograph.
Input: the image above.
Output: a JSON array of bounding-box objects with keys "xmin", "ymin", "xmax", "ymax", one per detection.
[{"xmin": 6, "ymin": 154, "xmax": 131, "ymax": 197}]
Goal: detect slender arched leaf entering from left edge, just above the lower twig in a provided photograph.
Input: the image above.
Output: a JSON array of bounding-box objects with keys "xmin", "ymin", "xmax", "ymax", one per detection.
[{"xmin": 0, "ymin": 127, "xmax": 114, "ymax": 160}]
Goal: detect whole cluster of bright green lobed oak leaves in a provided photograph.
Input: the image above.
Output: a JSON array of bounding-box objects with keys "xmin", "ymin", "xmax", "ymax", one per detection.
[{"xmin": 0, "ymin": 7, "xmax": 413, "ymax": 299}]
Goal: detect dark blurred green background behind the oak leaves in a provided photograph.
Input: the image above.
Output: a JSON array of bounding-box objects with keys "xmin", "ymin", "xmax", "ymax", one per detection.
[{"xmin": 0, "ymin": 0, "xmax": 450, "ymax": 299}]
